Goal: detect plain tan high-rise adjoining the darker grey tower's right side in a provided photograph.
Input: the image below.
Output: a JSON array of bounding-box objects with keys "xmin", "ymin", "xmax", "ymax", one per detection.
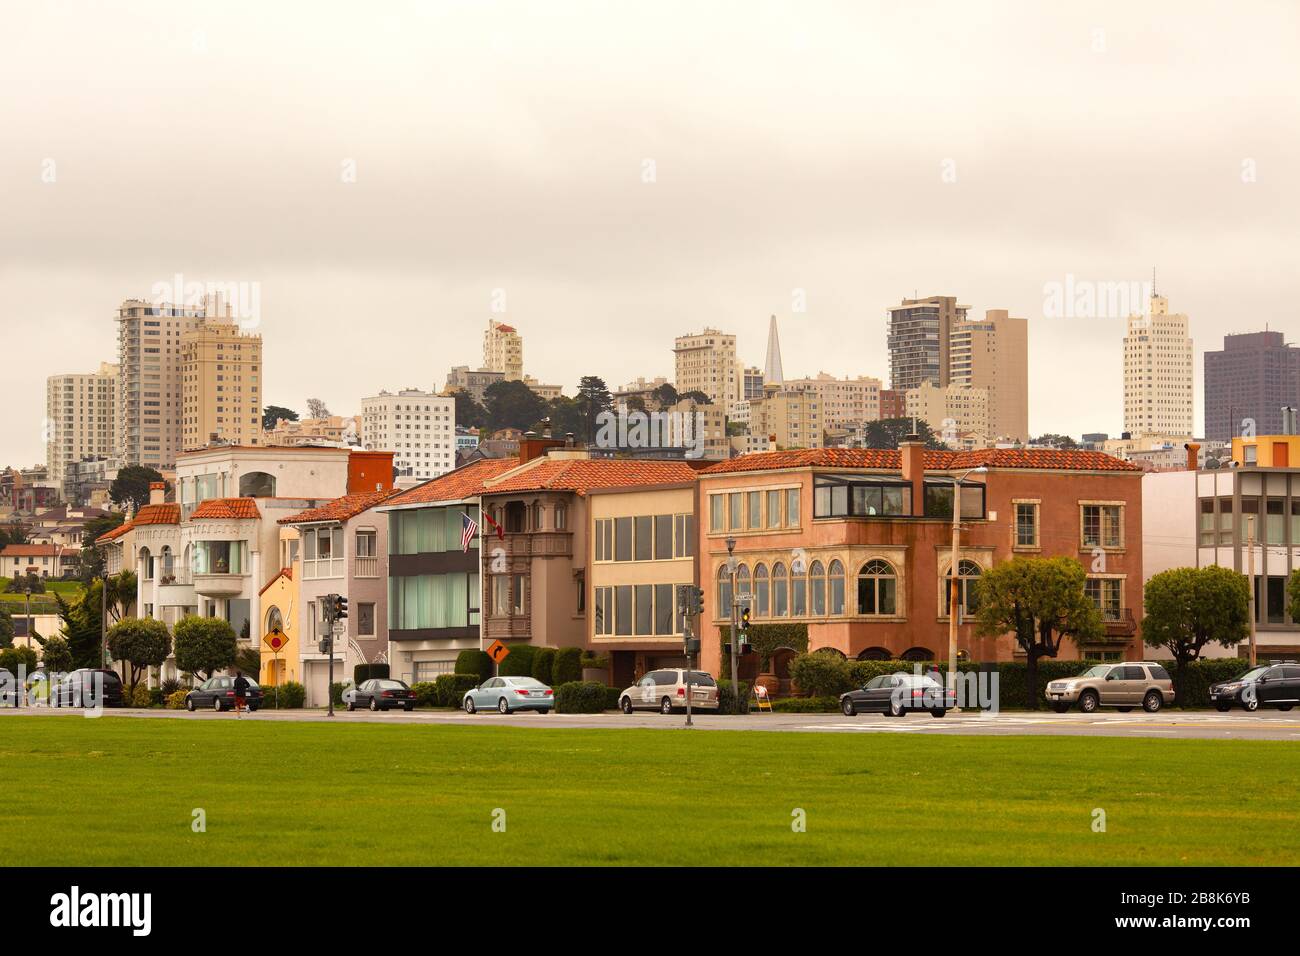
[{"xmin": 948, "ymin": 308, "xmax": 1030, "ymax": 441}]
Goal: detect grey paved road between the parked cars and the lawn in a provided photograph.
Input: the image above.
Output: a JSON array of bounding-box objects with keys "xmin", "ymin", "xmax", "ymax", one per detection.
[{"xmin": 0, "ymin": 708, "xmax": 1300, "ymax": 743}]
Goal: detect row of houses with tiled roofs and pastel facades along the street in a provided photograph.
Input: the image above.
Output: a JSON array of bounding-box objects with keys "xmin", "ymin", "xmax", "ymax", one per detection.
[{"xmin": 91, "ymin": 434, "xmax": 1300, "ymax": 704}]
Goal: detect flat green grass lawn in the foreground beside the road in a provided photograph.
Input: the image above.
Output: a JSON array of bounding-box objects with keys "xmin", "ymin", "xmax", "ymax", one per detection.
[{"xmin": 0, "ymin": 717, "xmax": 1300, "ymax": 865}]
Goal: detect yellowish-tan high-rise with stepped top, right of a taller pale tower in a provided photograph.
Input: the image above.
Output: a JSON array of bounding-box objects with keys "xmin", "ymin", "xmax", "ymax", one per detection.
[{"xmin": 181, "ymin": 304, "xmax": 267, "ymax": 451}]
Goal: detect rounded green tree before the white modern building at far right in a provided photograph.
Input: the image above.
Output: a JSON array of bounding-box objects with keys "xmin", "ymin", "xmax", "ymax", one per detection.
[{"xmin": 1141, "ymin": 564, "xmax": 1253, "ymax": 701}]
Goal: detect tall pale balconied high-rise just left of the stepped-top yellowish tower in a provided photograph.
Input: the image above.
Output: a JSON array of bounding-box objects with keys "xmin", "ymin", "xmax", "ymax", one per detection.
[{"xmin": 114, "ymin": 299, "xmax": 204, "ymax": 470}]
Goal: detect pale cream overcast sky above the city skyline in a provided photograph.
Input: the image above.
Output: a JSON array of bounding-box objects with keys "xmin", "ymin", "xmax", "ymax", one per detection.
[{"xmin": 0, "ymin": 0, "xmax": 1300, "ymax": 464}]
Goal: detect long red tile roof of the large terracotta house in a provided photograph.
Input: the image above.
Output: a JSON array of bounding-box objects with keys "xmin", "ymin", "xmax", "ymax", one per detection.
[{"xmin": 701, "ymin": 449, "xmax": 1141, "ymax": 475}]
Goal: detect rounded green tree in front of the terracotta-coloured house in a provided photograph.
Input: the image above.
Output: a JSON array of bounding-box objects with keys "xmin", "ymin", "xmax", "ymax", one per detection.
[{"xmin": 975, "ymin": 558, "xmax": 1105, "ymax": 710}]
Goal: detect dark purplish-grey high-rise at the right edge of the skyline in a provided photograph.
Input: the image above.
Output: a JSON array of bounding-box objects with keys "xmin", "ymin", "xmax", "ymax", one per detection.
[{"xmin": 1205, "ymin": 332, "xmax": 1300, "ymax": 441}]
